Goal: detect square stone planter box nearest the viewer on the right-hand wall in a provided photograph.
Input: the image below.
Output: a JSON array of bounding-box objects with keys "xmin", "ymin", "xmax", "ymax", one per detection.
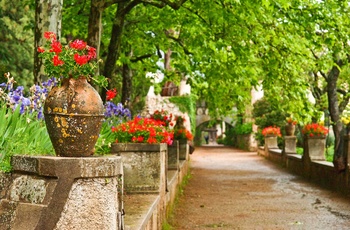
[{"xmin": 304, "ymin": 136, "xmax": 326, "ymax": 161}]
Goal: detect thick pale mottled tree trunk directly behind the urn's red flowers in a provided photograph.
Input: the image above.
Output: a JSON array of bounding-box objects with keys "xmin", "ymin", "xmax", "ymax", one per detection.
[{"xmin": 33, "ymin": 0, "xmax": 63, "ymax": 84}]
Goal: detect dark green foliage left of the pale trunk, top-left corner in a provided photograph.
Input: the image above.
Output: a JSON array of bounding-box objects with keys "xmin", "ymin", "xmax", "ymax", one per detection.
[{"xmin": 0, "ymin": 0, "xmax": 34, "ymax": 89}]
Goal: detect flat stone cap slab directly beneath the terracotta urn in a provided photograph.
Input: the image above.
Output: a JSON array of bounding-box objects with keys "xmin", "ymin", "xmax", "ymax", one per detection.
[{"xmin": 11, "ymin": 155, "xmax": 123, "ymax": 178}]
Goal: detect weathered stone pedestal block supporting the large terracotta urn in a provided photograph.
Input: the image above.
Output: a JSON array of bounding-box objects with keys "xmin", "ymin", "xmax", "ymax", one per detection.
[{"xmin": 1, "ymin": 156, "xmax": 123, "ymax": 230}]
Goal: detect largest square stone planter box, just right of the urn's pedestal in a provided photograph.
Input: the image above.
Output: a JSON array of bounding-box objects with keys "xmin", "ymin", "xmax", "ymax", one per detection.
[{"xmin": 111, "ymin": 143, "xmax": 168, "ymax": 193}]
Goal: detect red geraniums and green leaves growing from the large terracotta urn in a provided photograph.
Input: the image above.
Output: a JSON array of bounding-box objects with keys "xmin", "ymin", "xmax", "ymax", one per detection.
[{"xmin": 38, "ymin": 32, "xmax": 107, "ymax": 86}]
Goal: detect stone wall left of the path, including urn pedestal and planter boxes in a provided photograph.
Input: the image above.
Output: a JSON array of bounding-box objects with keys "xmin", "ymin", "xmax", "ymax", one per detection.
[{"xmin": 0, "ymin": 142, "xmax": 189, "ymax": 230}]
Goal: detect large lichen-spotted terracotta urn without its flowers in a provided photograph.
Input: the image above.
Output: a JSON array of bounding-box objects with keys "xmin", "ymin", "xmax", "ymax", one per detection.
[{"xmin": 44, "ymin": 77, "xmax": 104, "ymax": 157}]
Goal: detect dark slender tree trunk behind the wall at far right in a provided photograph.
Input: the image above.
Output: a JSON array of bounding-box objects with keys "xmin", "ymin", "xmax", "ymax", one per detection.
[{"xmin": 327, "ymin": 61, "xmax": 345, "ymax": 172}]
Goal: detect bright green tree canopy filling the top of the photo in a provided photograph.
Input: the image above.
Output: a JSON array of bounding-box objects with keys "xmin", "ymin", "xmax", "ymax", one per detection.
[{"xmin": 0, "ymin": 0, "xmax": 350, "ymax": 169}]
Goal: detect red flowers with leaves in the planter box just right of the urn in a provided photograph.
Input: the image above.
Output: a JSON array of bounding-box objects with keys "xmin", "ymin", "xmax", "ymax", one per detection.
[{"xmin": 112, "ymin": 117, "xmax": 174, "ymax": 145}]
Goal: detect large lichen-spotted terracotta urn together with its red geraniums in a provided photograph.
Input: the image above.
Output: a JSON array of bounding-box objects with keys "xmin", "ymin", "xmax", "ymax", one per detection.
[{"xmin": 38, "ymin": 32, "xmax": 105, "ymax": 157}]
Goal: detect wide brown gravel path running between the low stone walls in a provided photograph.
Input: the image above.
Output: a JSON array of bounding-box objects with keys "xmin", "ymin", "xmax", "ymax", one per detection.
[{"xmin": 170, "ymin": 147, "xmax": 350, "ymax": 230}]
